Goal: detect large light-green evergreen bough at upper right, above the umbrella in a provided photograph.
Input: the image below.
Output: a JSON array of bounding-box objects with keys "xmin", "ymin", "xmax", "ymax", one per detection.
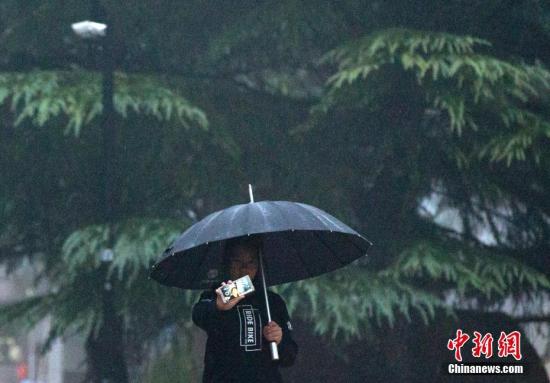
[{"xmin": 322, "ymin": 29, "xmax": 550, "ymax": 164}]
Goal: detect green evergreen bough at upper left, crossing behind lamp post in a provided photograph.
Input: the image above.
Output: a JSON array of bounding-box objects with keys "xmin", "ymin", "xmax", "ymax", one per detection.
[{"xmin": 0, "ymin": 70, "xmax": 208, "ymax": 136}]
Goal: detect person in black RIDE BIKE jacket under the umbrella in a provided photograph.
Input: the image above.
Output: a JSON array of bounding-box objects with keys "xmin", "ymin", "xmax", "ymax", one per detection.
[{"xmin": 192, "ymin": 236, "xmax": 298, "ymax": 382}]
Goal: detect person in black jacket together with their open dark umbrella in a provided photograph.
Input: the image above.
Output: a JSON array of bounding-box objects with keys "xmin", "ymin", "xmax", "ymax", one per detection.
[{"xmin": 150, "ymin": 189, "xmax": 372, "ymax": 382}]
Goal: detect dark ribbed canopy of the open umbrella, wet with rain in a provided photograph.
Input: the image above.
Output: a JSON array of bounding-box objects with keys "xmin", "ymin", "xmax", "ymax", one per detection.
[{"xmin": 150, "ymin": 201, "xmax": 372, "ymax": 289}]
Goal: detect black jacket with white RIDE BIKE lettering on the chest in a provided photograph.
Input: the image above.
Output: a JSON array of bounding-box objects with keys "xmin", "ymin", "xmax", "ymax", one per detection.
[{"xmin": 193, "ymin": 284, "xmax": 298, "ymax": 383}]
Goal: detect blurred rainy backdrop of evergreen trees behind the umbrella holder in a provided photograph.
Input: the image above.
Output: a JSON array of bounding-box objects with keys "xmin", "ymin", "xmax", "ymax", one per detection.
[{"xmin": 0, "ymin": 0, "xmax": 550, "ymax": 383}]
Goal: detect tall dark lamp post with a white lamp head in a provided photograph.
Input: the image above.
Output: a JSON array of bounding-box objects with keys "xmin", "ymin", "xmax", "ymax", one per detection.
[{"xmin": 71, "ymin": 0, "xmax": 128, "ymax": 383}]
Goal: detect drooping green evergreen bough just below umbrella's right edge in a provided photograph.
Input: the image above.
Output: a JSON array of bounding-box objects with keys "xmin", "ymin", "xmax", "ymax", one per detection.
[{"xmin": 276, "ymin": 266, "xmax": 450, "ymax": 340}]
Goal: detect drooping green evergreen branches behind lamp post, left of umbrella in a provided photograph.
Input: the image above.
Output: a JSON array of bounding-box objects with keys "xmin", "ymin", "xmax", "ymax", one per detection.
[{"xmin": 0, "ymin": 219, "xmax": 197, "ymax": 354}]
